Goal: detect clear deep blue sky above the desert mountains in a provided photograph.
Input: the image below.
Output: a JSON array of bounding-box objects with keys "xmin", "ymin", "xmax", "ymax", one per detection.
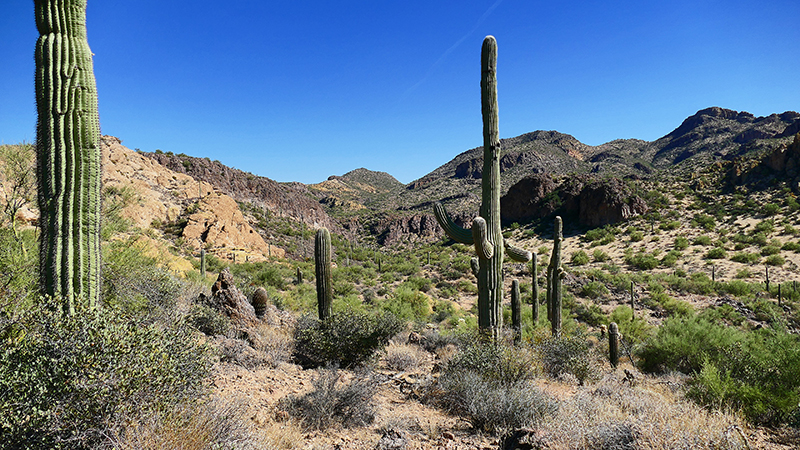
[{"xmin": 0, "ymin": 0, "xmax": 800, "ymax": 183}]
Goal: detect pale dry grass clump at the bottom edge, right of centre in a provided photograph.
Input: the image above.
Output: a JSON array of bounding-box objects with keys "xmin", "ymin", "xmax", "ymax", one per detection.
[{"xmin": 537, "ymin": 374, "xmax": 749, "ymax": 450}]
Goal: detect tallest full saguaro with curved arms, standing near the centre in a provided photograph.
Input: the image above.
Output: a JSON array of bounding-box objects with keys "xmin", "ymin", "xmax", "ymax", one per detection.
[{"xmin": 434, "ymin": 36, "xmax": 531, "ymax": 338}]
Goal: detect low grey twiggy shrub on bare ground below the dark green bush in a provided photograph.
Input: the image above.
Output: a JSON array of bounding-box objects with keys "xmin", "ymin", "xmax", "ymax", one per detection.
[{"xmin": 278, "ymin": 366, "xmax": 377, "ymax": 430}]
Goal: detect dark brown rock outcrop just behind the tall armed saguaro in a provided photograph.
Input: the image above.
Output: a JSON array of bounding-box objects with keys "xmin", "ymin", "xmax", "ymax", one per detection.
[{"xmin": 500, "ymin": 174, "xmax": 647, "ymax": 227}]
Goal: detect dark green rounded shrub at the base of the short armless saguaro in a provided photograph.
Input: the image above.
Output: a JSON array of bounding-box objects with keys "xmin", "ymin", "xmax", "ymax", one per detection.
[{"xmin": 294, "ymin": 310, "xmax": 402, "ymax": 367}]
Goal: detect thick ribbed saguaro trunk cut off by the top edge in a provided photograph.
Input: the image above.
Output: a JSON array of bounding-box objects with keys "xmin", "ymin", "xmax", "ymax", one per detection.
[{"xmin": 34, "ymin": 0, "xmax": 101, "ymax": 313}]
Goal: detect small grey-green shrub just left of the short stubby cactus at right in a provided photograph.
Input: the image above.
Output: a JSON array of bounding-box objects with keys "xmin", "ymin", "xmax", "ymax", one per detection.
[{"xmin": 538, "ymin": 328, "xmax": 599, "ymax": 385}]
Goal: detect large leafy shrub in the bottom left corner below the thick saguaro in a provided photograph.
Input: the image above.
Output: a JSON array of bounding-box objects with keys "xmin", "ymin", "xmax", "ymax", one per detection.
[{"xmin": 0, "ymin": 300, "xmax": 211, "ymax": 449}]
